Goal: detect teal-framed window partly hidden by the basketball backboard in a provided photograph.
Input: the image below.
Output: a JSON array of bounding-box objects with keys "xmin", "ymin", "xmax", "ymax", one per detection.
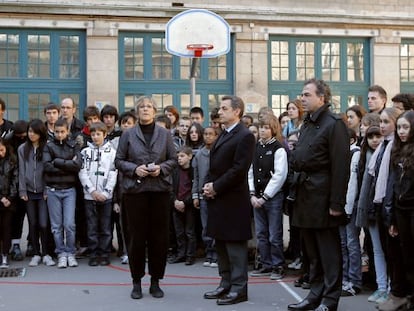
[{"xmin": 119, "ymin": 32, "xmax": 234, "ymax": 125}]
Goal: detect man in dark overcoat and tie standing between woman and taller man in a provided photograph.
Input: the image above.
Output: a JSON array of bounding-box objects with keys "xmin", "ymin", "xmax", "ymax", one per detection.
[{"xmin": 203, "ymin": 96, "xmax": 255, "ymax": 305}]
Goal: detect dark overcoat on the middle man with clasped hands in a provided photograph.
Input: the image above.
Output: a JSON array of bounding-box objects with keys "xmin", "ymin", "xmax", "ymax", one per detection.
[{"xmin": 206, "ymin": 123, "xmax": 255, "ymax": 241}]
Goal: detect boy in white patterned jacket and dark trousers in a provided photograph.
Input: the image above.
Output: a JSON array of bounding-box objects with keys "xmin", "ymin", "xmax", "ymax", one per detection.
[{"xmin": 79, "ymin": 122, "xmax": 118, "ymax": 266}]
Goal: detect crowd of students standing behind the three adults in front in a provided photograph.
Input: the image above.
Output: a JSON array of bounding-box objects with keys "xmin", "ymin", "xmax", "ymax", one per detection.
[{"xmin": 0, "ymin": 85, "xmax": 414, "ymax": 311}]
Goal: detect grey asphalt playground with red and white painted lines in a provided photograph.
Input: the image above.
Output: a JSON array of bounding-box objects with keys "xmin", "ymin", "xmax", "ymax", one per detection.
[{"xmin": 0, "ymin": 251, "xmax": 382, "ymax": 311}]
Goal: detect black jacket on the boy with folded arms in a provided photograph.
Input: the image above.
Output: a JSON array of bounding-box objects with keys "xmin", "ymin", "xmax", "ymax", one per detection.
[{"xmin": 43, "ymin": 140, "xmax": 82, "ymax": 189}]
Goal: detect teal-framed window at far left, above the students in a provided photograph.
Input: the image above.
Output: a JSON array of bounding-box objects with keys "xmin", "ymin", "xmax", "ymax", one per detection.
[{"xmin": 0, "ymin": 29, "xmax": 86, "ymax": 121}]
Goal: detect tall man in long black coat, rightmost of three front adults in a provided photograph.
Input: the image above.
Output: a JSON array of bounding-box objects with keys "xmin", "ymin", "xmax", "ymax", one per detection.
[{"xmin": 288, "ymin": 79, "xmax": 350, "ymax": 311}]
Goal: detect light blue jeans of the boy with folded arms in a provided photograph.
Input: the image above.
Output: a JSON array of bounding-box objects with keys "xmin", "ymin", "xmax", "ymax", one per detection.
[{"xmin": 46, "ymin": 187, "xmax": 76, "ymax": 257}]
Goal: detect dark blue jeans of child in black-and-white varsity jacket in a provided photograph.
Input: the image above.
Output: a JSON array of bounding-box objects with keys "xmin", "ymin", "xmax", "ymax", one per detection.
[{"xmin": 253, "ymin": 192, "xmax": 285, "ymax": 268}]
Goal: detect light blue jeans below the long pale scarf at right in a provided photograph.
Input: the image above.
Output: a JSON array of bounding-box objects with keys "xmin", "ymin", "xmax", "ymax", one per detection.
[{"xmin": 368, "ymin": 222, "xmax": 388, "ymax": 291}]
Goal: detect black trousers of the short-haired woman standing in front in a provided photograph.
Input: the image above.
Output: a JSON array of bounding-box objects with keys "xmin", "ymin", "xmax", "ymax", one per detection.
[{"xmin": 122, "ymin": 192, "xmax": 169, "ymax": 282}]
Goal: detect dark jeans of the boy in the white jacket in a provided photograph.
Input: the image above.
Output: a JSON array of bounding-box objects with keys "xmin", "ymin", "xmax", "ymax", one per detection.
[{"xmin": 85, "ymin": 200, "xmax": 112, "ymax": 257}]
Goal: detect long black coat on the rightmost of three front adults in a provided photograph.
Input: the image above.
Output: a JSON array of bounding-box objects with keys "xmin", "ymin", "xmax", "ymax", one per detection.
[{"xmin": 291, "ymin": 104, "xmax": 350, "ymax": 228}]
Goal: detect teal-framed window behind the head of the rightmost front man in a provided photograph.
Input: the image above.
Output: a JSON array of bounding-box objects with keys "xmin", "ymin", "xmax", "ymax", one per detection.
[{"xmin": 269, "ymin": 36, "xmax": 370, "ymax": 115}]
